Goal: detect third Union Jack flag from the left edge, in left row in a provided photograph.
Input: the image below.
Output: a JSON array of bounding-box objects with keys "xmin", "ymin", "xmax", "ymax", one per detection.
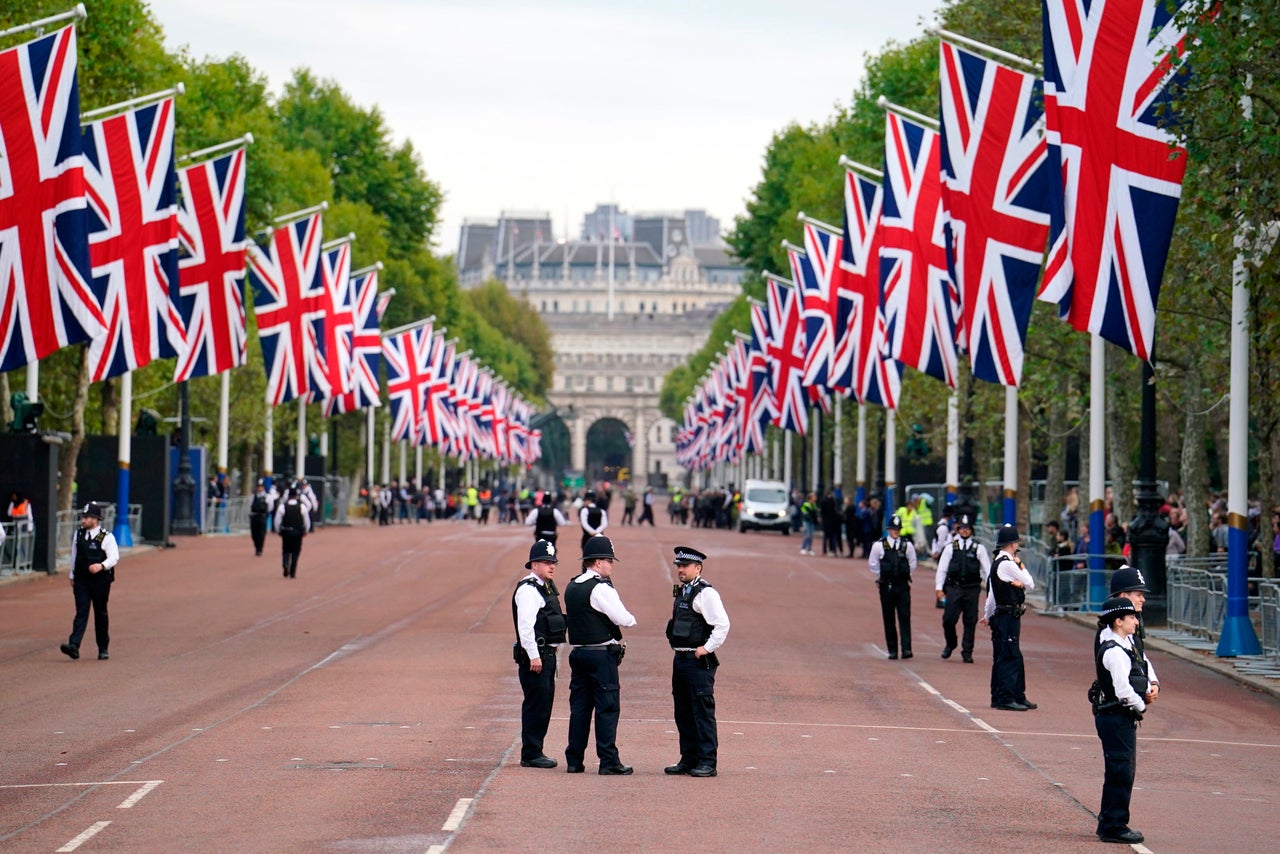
[{"xmin": 173, "ymin": 149, "xmax": 247, "ymax": 383}]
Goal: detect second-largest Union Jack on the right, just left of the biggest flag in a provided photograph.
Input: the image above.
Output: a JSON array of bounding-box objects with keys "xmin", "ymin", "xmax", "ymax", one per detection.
[{"xmin": 940, "ymin": 41, "xmax": 1050, "ymax": 385}]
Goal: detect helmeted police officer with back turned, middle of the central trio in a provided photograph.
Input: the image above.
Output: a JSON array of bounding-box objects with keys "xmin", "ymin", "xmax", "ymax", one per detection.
[{"xmin": 564, "ymin": 536, "xmax": 636, "ymax": 775}]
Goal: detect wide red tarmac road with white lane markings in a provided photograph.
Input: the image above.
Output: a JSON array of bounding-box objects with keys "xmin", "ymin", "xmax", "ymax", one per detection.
[{"xmin": 0, "ymin": 522, "xmax": 1280, "ymax": 854}]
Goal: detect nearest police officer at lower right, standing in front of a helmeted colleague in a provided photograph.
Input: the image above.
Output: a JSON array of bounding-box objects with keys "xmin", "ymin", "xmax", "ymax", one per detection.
[{"xmin": 1089, "ymin": 597, "xmax": 1156, "ymax": 845}]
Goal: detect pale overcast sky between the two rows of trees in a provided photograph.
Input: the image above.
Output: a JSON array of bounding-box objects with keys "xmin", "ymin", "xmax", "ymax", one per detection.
[{"xmin": 151, "ymin": 0, "xmax": 941, "ymax": 252}]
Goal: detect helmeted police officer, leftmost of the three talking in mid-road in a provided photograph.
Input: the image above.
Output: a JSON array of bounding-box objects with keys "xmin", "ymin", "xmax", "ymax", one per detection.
[{"xmin": 511, "ymin": 540, "xmax": 564, "ymax": 768}]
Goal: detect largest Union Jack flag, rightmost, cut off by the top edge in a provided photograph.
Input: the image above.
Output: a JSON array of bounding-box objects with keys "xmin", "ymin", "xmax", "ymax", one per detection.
[{"xmin": 1039, "ymin": 0, "xmax": 1187, "ymax": 360}]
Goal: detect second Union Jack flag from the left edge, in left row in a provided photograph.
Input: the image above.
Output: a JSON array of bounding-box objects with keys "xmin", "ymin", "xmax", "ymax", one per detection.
[{"xmin": 84, "ymin": 97, "xmax": 187, "ymax": 382}]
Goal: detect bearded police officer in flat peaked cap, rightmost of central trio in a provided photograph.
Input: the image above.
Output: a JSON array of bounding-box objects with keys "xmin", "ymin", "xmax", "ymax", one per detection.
[{"xmin": 664, "ymin": 545, "xmax": 728, "ymax": 777}]
